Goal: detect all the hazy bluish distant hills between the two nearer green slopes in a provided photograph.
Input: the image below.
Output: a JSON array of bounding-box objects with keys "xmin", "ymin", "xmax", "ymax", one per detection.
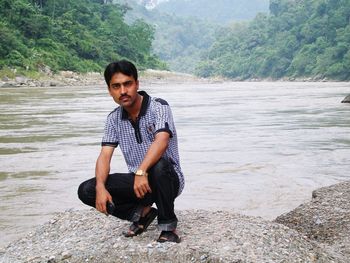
[{"xmin": 118, "ymin": 0, "xmax": 269, "ymax": 74}]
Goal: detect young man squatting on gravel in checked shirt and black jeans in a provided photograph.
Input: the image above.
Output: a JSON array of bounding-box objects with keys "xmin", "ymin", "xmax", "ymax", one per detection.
[{"xmin": 78, "ymin": 60, "xmax": 184, "ymax": 243}]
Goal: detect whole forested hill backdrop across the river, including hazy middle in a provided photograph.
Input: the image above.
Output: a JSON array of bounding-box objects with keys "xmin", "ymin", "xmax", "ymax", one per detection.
[{"xmin": 0, "ymin": 0, "xmax": 350, "ymax": 80}]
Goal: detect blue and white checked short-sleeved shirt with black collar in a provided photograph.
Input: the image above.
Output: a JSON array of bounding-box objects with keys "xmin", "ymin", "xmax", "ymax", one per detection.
[{"xmin": 102, "ymin": 91, "xmax": 185, "ymax": 194}]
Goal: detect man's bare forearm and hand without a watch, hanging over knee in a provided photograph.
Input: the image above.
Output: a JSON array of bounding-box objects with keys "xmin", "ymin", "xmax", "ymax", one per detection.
[{"xmin": 95, "ymin": 146, "xmax": 114, "ymax": 214}]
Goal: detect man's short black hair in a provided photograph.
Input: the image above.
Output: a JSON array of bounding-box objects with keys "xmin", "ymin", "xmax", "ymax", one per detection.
[{"xmin": 104, "ymin": 59, "xmax": 137, "ymax": 87}]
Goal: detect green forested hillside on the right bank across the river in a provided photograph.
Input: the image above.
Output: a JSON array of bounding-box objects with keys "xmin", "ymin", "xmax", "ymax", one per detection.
[{"xmin": 196, "ymin": 0, "xmax": 350, "ymax": 80}]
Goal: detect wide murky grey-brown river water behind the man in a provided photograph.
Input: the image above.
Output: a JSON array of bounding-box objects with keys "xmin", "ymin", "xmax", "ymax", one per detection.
[{"xmin": 0, "ymin": 82, "xmax": 350, "ymax": 246}]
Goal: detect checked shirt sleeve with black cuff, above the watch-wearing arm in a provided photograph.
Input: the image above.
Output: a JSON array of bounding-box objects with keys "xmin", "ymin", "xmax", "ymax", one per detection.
[{"xmin": 155, "ymin": 99, "xmax": 175, "ymax": 138}]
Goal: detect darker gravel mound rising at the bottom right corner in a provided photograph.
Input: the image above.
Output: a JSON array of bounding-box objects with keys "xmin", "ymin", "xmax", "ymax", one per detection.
[{"xmin": 275, "ymin": 182, "xmax": 350, "ymax": 258}]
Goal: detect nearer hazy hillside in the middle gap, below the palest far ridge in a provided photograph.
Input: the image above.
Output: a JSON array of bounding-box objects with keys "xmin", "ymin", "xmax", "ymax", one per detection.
[{"xmin": 118, "ymin": 0, "xmax": 226, "ymax": 73}]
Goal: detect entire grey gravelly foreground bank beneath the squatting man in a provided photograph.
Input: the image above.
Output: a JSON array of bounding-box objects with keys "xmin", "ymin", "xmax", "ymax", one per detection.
[{"xmin": 0, "ymin": 182, "xmax": 350, "ymax": 263}]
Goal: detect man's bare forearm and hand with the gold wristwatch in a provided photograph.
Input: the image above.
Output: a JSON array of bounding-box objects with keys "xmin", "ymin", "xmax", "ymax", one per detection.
[{"xmin": 134, "ymin": 132, "xmax": 170, "ymax": 198}]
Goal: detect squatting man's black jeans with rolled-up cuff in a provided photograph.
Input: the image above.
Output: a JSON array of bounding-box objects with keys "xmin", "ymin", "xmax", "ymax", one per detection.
[{"xmin": 78, "ymin": 158, "xmax": 179, "ymax": 231}]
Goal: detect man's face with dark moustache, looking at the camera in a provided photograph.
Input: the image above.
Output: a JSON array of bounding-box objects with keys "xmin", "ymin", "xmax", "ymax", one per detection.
[{"xmin": 108, "ymin": 73, "xmax": 139, "ymax": 109}]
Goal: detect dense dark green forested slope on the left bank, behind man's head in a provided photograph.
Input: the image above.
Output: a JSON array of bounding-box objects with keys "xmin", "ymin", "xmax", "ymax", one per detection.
[{"xmin": 0, "ymin": 0, "xmax": 165, "ymax": 72}]
